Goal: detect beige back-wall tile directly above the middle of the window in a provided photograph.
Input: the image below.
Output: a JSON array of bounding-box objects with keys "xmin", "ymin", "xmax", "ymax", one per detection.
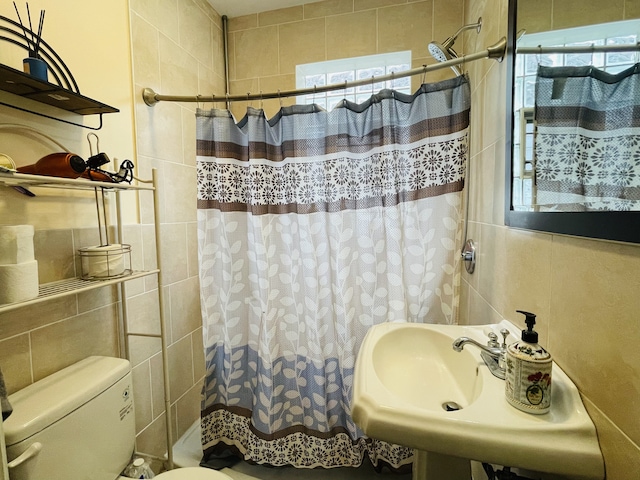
[{"xmin": 326, "ymin": 10, "xmax": 378, "ymax": 60}]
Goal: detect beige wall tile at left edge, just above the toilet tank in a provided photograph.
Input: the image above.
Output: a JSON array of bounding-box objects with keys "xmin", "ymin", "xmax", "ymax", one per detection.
[{"xmin": 0, "ymin": 334, "xmax": 33, "ymax": 395}]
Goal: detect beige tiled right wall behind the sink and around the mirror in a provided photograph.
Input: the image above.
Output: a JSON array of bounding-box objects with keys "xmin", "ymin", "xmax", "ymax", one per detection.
[{"xmin": 460, "ymin": 0, "xmax": 640, "ymax": 480}]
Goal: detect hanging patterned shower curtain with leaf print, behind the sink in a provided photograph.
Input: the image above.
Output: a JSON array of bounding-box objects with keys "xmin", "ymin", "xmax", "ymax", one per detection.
[{"xmin": 197, "ymin": 77, "xmax": 470, "ymax": 469}]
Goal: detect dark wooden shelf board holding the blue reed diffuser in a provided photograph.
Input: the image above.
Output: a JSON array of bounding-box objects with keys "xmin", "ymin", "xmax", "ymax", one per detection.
[{"xmin": 0, "ymin": 65, "xmax": 120, "ymax": 115}]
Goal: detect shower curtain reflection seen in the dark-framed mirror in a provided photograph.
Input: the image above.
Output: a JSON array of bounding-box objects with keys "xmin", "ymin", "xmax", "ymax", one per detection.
[{"xmin": 535, "ymin": 64, "xmax": 640, "ymax": 211}]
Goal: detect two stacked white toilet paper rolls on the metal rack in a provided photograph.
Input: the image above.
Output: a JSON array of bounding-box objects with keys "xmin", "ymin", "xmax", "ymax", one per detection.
[{"xmin": 0, "ymin": 225, "xmax": 38, "ymax": 304}]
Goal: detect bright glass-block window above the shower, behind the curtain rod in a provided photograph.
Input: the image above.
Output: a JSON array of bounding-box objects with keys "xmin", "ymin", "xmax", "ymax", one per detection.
[{"xmin": 296, "ymin": 50, "xmax": 411, "ymax": 110}]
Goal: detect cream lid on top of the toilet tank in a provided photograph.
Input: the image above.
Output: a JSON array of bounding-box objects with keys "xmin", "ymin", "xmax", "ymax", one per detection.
[{"xmin": 3, "ymin": 356, "xmax": 131, "ymax": 446}]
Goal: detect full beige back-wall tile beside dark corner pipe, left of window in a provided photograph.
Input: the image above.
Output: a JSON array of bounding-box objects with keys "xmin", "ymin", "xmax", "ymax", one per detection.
[{"xmin": 233, "ymin": 26, "xmax": 279, "ymax": 79}]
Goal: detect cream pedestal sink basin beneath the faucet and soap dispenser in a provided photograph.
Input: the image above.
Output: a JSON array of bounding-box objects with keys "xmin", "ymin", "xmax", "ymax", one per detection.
[{"xmin": 352, "ymin": 321, "xmax": 604, "ymax": 480}]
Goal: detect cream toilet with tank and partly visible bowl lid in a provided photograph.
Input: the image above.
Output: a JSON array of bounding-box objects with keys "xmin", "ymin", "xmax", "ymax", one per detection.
[{"xmin": 3, "ymin": 357, "xmax": 231, "ymax": 480}]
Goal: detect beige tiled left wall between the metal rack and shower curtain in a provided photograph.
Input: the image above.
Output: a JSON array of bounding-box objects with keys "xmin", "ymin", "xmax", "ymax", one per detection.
[{"xmin": 129, "ymin": 0, "xmax": 224, "ymax": 454}]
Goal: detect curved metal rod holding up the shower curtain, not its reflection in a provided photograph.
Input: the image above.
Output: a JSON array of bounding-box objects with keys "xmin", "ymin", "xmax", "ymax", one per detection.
[{"xmin": 142, "ymin": 37, "xmax": 507, "ymax": 107}]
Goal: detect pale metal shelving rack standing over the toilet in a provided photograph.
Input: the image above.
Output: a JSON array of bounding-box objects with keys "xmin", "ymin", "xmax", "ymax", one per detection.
[{"xmin": 0, "ymin": 169, "xmax": 173, "ymax": 469}]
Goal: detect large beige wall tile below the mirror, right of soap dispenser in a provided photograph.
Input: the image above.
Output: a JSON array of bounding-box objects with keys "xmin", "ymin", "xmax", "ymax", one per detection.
[{"xmin": 549, "ymin": 236, "xmax": 640, "ymax": 443}]
